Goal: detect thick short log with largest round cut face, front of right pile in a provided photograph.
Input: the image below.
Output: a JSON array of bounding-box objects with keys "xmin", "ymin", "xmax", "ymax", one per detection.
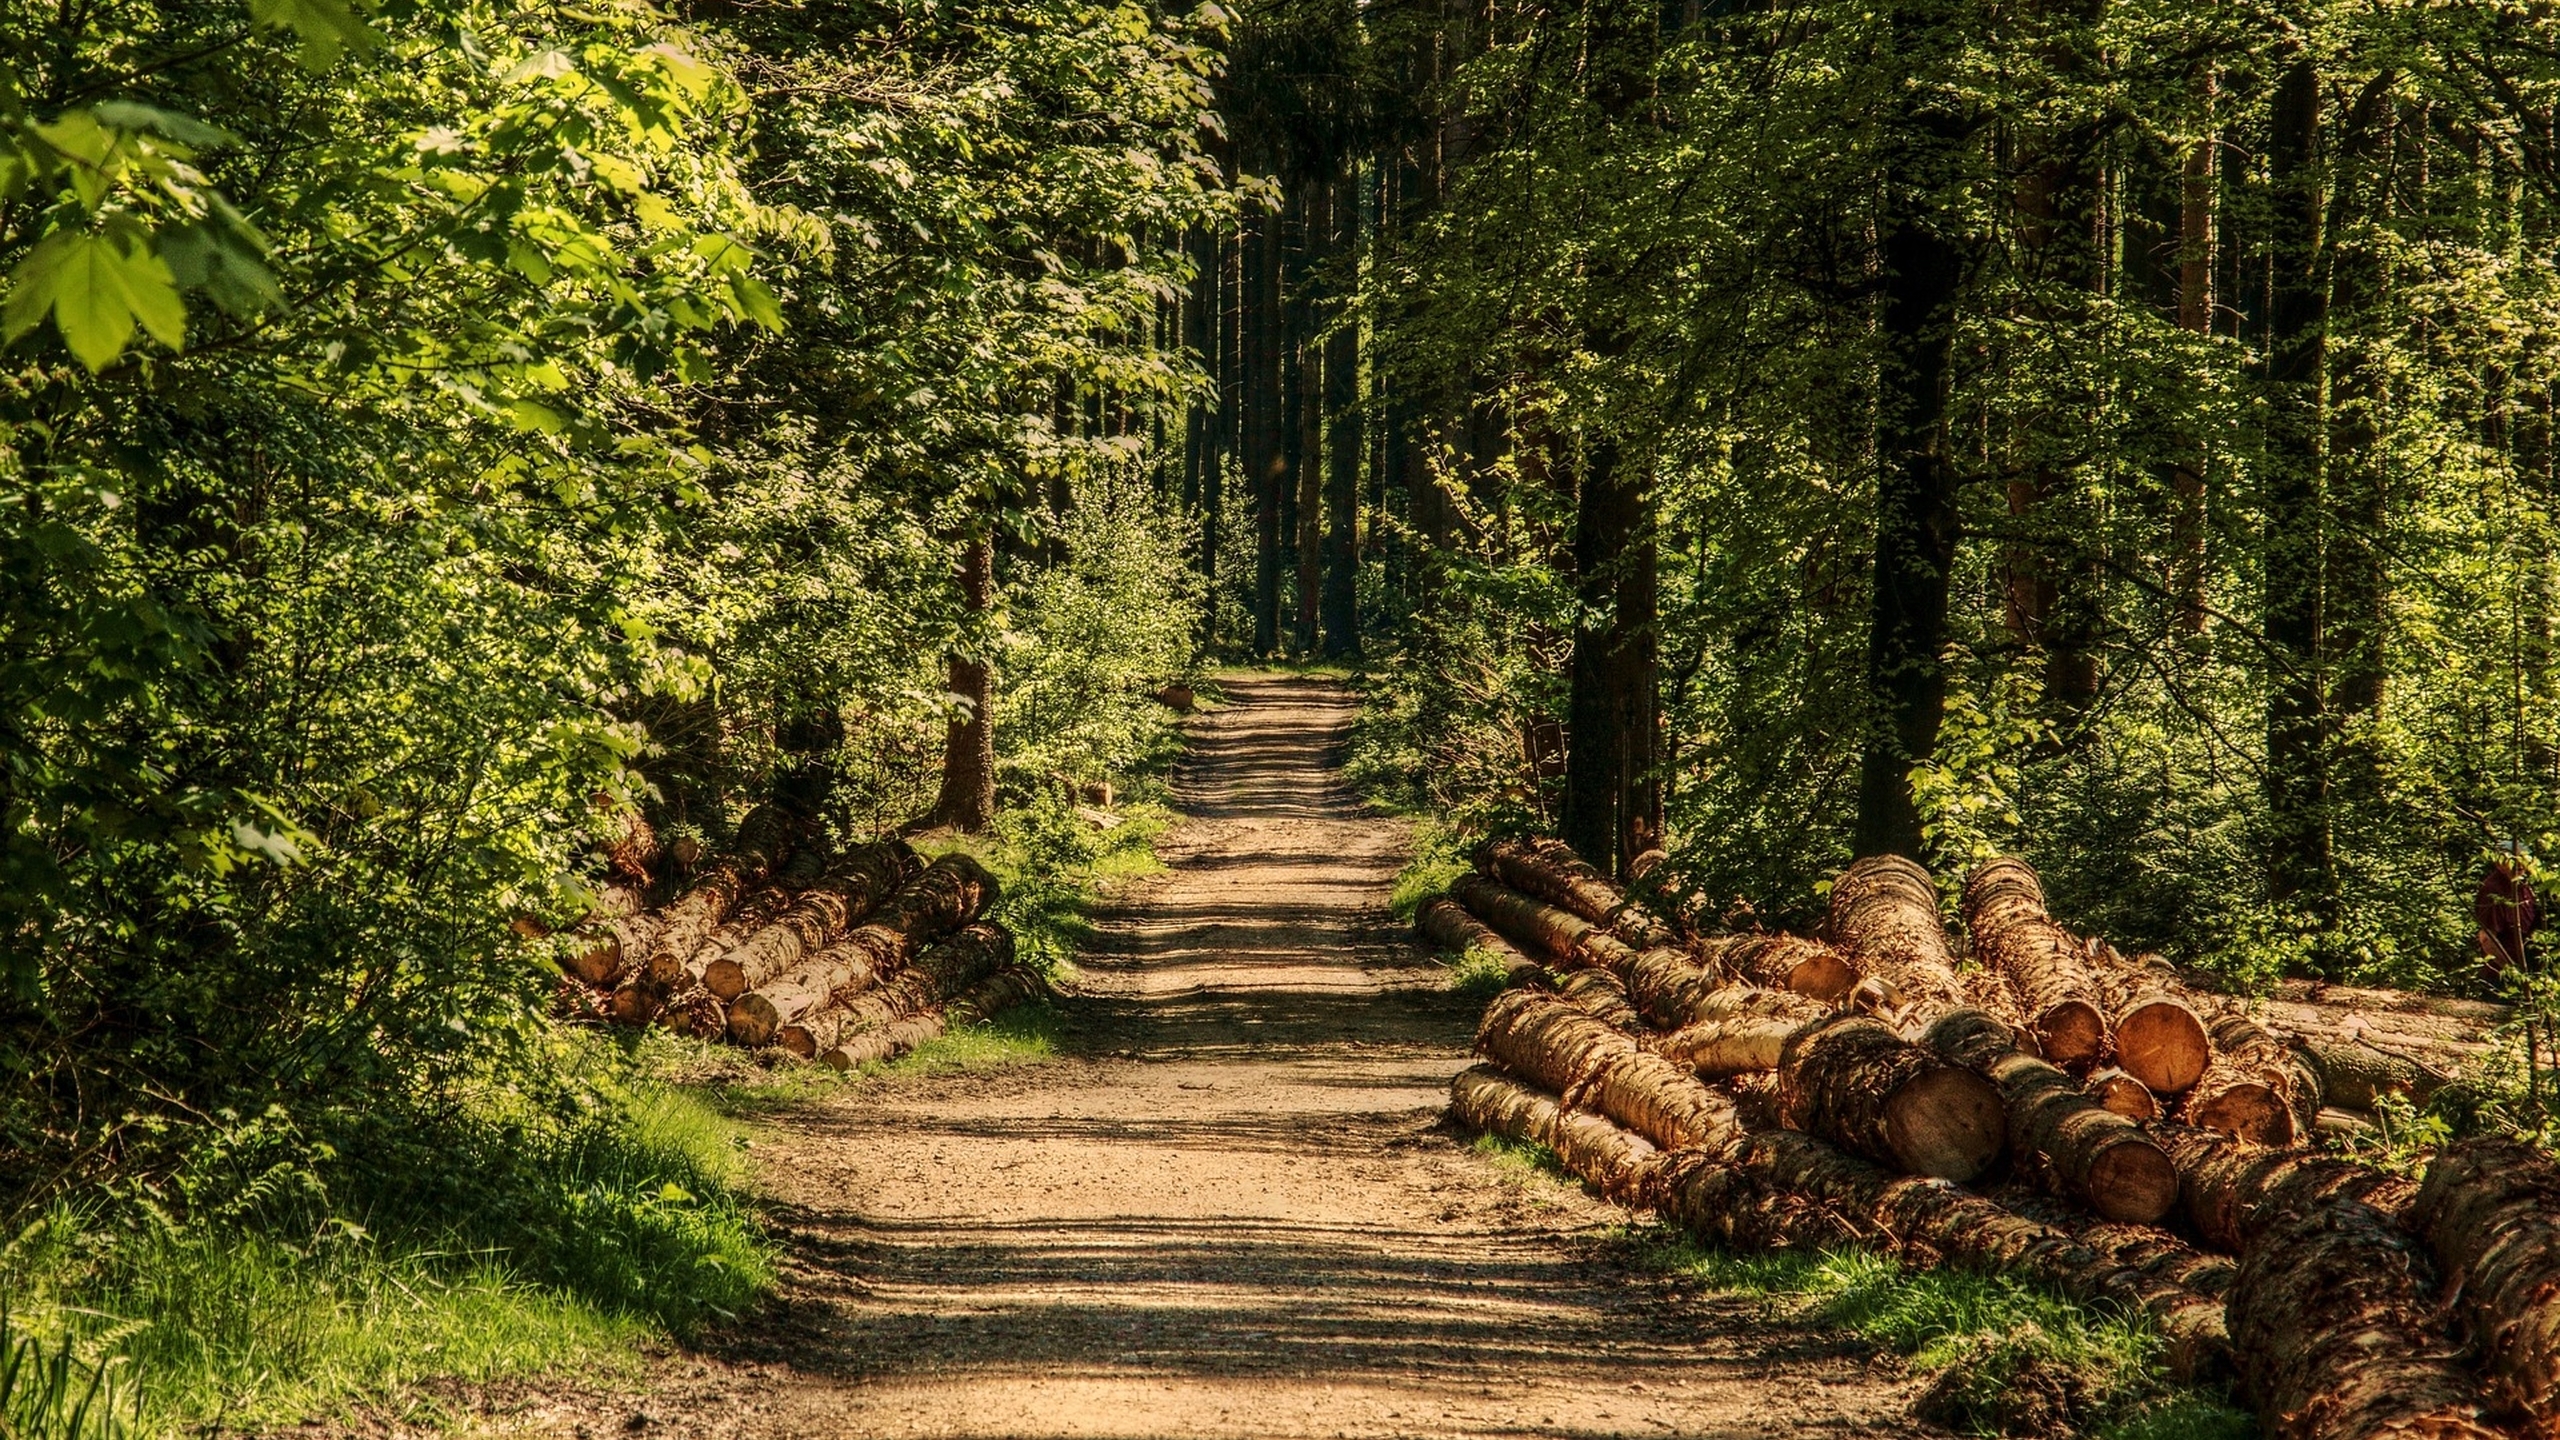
[{"xmin": 1777, "ymin": 1015, "xmax": 2007, "ymax": 1184}]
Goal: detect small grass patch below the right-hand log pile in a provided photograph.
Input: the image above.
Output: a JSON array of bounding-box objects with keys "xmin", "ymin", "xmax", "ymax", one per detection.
[{"xmin": 1636, "ymin": 1232, "xmax": 2258, "ymax": 1440}]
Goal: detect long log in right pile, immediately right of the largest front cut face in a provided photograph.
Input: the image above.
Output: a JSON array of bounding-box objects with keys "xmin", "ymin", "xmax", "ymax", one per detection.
[{"xmin": 1925, "ymin": 1010, "xmax": 2179, "ymax": 1225}]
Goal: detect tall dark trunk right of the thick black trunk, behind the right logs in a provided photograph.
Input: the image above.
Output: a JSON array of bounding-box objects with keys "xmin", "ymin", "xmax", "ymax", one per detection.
[{"xmin": 2263, "ymin": 54, "xmax": 2335, "ymax": 930}]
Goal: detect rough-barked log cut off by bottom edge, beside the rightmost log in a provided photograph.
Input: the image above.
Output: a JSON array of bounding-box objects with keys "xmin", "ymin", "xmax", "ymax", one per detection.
[{"xmin": 2230, "ymin": 1199, "xmax": 2501, "ymax": 1440}]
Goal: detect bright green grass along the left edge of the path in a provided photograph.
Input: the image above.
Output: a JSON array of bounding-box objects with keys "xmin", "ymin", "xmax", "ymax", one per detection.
[{"xmin": 0, "ymin": 1035, "xmax": 773, "ymax": 1437}]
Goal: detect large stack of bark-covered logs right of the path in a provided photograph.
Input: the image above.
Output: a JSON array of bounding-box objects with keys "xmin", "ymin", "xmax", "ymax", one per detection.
[{"xmin": 1418, "ymin": 840, "xmax": 2560, "ymax": 1440}]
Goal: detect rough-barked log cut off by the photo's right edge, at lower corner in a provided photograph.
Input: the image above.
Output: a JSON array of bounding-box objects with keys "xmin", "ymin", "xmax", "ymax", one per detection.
[{"xmin": 2409, "ymin": 1135, "xmax": 2560, "ymax": 1435}]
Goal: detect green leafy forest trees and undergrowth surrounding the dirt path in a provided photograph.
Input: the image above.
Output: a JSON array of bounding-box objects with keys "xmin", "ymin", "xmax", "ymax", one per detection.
[{"xmin": 15, "ymin": 0, "xmax": 2560, "ymax": 1435}]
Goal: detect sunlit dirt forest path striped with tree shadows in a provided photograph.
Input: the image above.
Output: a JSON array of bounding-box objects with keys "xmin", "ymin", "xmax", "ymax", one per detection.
[{"xmin": 563, "ymin": 676, "xmax": 1920, "ymax": 1440}]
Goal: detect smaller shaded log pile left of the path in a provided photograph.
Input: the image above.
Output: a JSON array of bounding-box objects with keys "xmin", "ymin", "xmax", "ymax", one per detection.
[{"xmin": 561, "ymin": 807, "xmax": 1047, "ymax": 1068}]
